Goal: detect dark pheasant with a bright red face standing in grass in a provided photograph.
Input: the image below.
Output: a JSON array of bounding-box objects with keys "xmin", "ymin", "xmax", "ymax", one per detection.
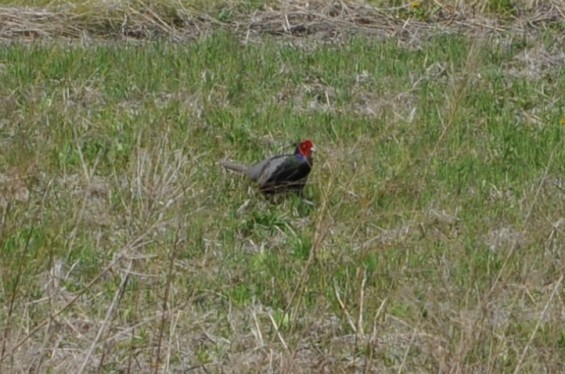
[{"xmin": 220, "ymin": 139, "xmax": 316, "ymax": 196}]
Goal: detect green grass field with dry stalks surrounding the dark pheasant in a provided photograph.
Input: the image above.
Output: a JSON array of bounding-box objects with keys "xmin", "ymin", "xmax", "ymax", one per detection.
[{"xmin": 0, "ymin": 1, "xmax": 565, "ymax": 373}]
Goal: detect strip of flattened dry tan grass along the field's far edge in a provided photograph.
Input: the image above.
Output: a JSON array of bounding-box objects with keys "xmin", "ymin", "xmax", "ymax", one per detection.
[{"xmin": 0, "ymin": 0, "xmax": 565, "ymax": 41}]
